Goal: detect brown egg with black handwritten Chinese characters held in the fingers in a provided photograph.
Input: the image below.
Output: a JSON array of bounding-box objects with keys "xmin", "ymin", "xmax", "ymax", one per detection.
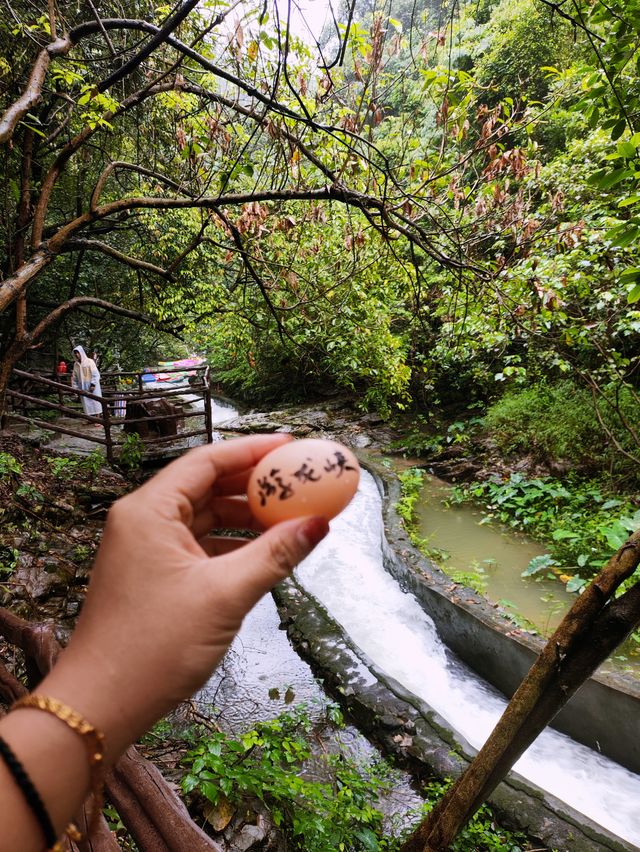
[{"xmin": 247, "ymin": 438, "xmax": 360, "ymax": 527}]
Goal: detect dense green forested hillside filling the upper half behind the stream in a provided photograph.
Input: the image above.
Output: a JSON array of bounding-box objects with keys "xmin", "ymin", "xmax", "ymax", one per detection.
[{"xmin": 0, "ymin": 0, "xmax": 640, "ymax": 476}]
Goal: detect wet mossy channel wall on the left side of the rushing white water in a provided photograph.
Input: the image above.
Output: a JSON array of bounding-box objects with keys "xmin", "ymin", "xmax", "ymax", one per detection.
[{"xmin": 274, "ymin": 579, "xmax": 637, "ymax": 852}]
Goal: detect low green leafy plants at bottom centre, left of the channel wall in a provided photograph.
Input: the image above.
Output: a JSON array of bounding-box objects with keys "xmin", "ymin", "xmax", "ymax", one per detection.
[{"xmin": 182, "ymin": 705, "xmax": 396, "ymax": 852}]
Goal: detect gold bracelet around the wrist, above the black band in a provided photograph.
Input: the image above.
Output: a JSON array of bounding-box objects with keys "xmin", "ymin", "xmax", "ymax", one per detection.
[{"xmin": 11, "ymin": 694, "xmax": 104, "ymax": 852}]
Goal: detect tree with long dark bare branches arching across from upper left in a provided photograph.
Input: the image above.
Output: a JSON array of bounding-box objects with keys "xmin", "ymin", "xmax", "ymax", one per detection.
[{"xmin": 0, "ymin": 2, "xmax": 560, "ymax": 416}]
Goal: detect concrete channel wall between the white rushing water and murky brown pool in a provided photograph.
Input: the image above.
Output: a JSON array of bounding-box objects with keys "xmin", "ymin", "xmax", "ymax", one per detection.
[{"xmin": 376, "ymin": 466, "xmax": 640, "ymax": 774}]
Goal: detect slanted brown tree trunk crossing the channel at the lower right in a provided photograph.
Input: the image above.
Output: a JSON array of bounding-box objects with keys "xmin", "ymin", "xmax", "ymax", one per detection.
[{"xmin": 400, "ymin": 531, "xmax": 640, "ymax": 852}]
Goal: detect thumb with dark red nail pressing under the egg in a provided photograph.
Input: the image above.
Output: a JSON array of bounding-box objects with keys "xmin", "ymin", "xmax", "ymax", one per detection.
[{"xmin": 225, "ymin": 517, "xmax": 329, "ymax": 611}]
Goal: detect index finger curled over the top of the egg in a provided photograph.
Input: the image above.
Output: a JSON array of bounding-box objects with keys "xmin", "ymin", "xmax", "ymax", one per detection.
[{"xmin": 143, "ymin": 433, "xmax": 292, "ymax": 503}]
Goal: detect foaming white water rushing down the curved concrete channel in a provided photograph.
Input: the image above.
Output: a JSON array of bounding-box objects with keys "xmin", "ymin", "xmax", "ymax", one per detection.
[{"xmin": 297, "ymin": 471, "xmax": 640, "ymax": 846}]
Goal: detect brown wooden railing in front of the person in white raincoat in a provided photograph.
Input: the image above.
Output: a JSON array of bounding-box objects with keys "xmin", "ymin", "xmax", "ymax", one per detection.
[{"xmin": 7, "ymin": 364, "xmax": 213, "ymax": 462}]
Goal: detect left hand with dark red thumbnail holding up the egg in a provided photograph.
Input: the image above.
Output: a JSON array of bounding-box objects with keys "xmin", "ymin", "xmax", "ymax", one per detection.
[{"xmin": 39, "ymin": 435, "xmax": 328, "ymax": 761}]
